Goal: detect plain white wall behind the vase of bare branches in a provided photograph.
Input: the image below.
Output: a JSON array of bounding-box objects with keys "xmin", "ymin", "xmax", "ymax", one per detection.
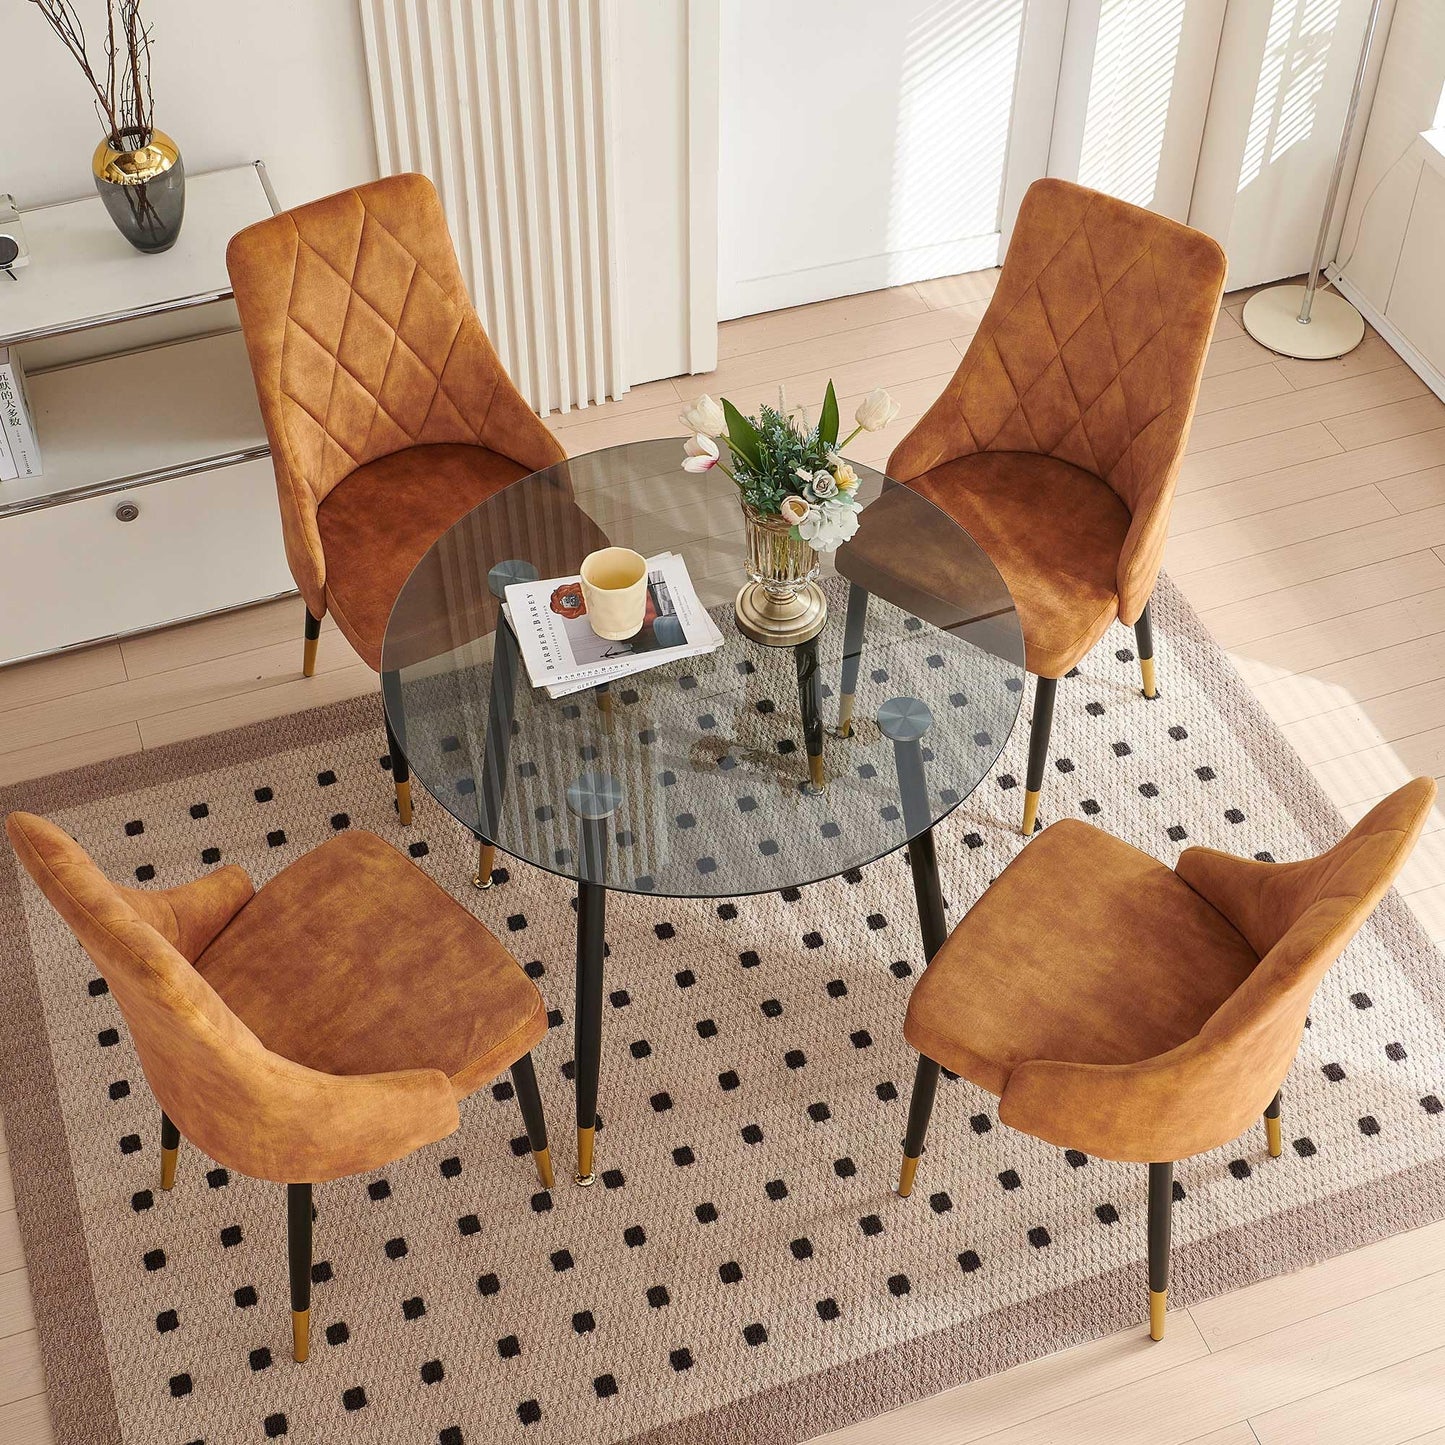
[{"xmin": 0, "ymin": 0, "xmax": 376, "ymax": 207}]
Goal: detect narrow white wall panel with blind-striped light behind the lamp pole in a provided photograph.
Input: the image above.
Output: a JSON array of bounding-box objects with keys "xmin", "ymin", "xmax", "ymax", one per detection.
[{"xmin": 1189, "ymin": 0, "xmax": 1381, "ymax": 289}]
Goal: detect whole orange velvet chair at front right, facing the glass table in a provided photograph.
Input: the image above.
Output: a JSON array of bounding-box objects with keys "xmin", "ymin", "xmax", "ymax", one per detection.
[{"xmin": 899, "ymin": 777, "xmax": 1435, "ymax": 1340}]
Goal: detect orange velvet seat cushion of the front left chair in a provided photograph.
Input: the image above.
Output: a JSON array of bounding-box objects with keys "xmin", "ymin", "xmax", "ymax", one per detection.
[{"xmin": 195, "ymin": 831, "xmax": 546, "ymax": 1098}]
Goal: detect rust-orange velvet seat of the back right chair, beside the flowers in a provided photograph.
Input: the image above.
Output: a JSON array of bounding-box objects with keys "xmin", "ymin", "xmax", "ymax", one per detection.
[{"xmin": 838, "ymin": 451, "xmax": 1130, "ymax": 678}]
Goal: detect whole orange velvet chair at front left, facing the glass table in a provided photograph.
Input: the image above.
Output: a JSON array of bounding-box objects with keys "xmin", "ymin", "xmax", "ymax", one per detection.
[{"xmin": 6, "ymin": 812, "xmax": 552, "ymax": 1360}]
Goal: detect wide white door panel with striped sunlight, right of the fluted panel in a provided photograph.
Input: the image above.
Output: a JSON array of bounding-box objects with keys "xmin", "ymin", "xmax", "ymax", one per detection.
[{"xmin": 718, "ymin": 0, "xmax": 1025, "ymax": 318}]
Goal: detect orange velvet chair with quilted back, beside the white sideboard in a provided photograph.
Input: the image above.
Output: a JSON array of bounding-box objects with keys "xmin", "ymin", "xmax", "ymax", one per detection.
[{"xmin": 225, "ymin": 175, "xmax": 607, "ymax": 843}]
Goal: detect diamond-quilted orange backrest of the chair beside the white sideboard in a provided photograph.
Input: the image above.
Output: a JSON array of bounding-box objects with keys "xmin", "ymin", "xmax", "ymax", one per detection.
[{"xmin": 225, "ymin": 175, "xmax": 564, "ymax": 616}]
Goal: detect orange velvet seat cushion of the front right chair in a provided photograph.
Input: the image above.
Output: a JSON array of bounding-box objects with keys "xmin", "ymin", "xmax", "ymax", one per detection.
[{"xmin": 903, "ymin": 819, "xmax": 1259, "ymax": 1094}]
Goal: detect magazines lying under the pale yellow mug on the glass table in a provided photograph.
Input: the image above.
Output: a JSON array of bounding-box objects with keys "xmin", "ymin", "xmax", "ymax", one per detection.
[{"xmin": 504, "ymin": 552, "xmax": 723, "ymax": 698}]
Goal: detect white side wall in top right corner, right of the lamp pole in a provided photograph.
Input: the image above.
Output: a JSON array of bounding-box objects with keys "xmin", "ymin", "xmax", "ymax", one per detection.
[{"xmin": 1338, "ymin": 0, "xmax": 1445, "ymax": 311}]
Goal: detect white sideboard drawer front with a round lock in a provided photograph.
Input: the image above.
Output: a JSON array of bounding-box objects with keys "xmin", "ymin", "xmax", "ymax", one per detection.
[{"xmin": 0, "ymin": 457, "xmax": 295, "ymax": 663}]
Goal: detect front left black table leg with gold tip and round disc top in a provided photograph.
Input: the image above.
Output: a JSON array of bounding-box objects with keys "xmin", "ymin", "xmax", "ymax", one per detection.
[{"xmin": 566, "ymin": 773, "xmax": 623, "ymax": 1189}]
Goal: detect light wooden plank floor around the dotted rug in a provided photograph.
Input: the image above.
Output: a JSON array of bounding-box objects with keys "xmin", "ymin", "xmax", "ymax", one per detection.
[{"xmin": 0, "ymin": 273, "xmax": 1445, "ymax": 1445}]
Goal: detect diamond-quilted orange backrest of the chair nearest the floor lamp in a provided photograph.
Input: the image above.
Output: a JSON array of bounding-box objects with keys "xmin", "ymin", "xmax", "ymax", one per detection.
[{"xmin": 887, "ymin": 179, "xmax": 1225, "ymax": 621}]
